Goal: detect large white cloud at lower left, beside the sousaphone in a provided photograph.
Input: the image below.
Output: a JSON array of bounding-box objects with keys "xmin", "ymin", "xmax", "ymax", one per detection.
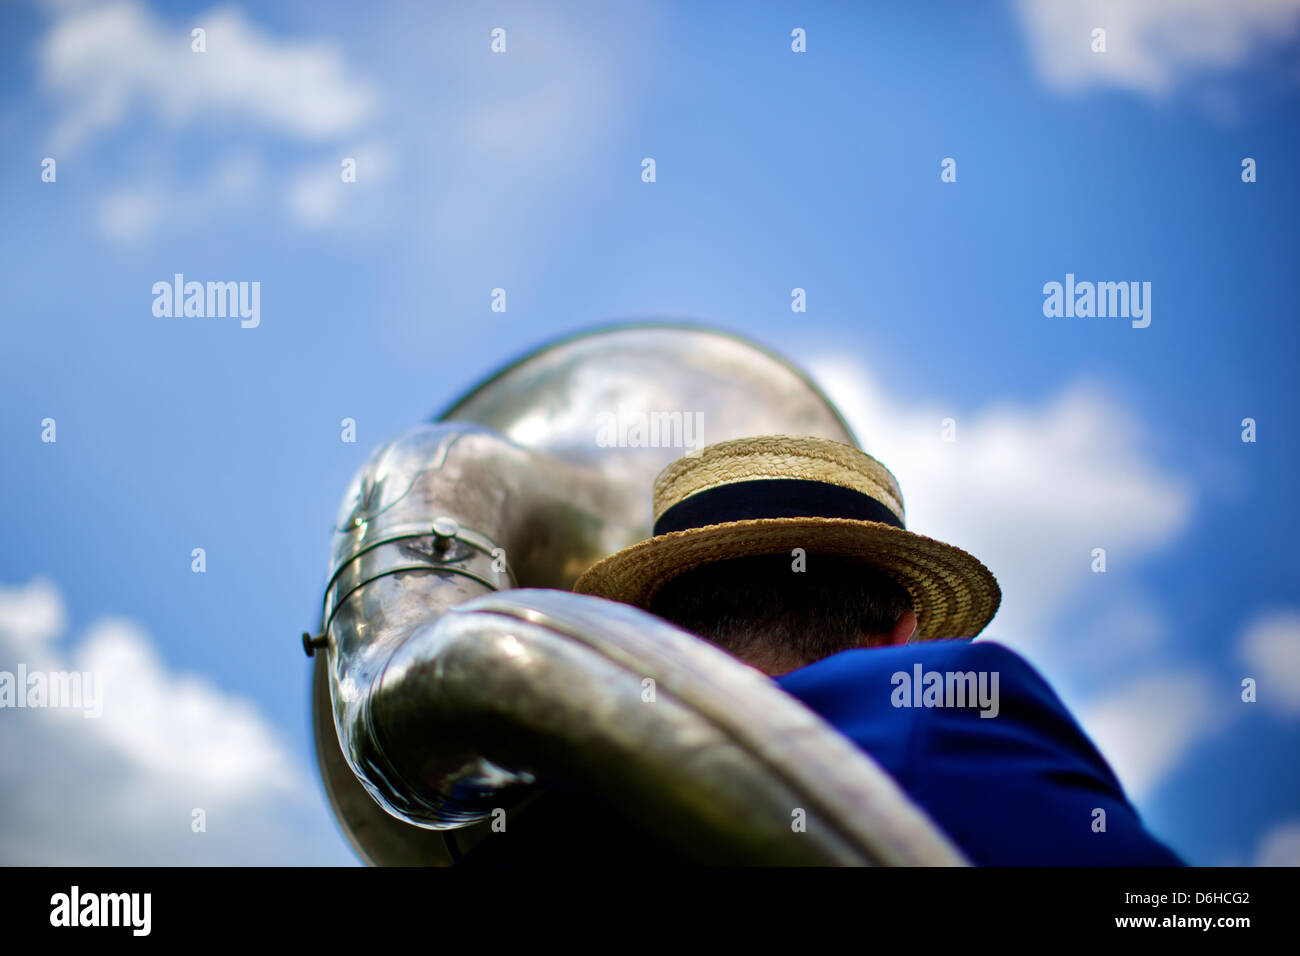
[{"xmin": 0, "ymin": 580, "xmax": 348, "ymax": 865}]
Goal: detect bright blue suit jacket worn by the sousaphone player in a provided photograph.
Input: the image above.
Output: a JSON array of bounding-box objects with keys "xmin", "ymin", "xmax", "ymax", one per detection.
[{"xmin": 776, "ymin": 640, "xmax": 1182, "ymax": 866}]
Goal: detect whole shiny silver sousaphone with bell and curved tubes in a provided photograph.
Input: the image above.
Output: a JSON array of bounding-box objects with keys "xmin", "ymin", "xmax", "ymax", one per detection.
[{"xmin": 313, "ymin": 325, "xmax": 959, "ymax": 864}]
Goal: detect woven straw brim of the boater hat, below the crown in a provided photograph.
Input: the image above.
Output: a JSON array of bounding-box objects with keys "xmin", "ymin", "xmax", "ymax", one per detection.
[{"xmin": 573, "ymin": 518, "xmax": 1002, "ymax": 640}]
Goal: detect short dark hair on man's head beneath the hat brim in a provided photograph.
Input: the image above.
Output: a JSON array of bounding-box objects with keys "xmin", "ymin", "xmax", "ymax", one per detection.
[{"xmin": 650, "ymin": 554, "xmax": 911, "ymax": 663}]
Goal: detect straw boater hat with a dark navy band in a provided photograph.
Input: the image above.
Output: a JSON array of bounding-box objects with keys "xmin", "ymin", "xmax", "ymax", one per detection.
[{"xmin": 573, "ymin": 434, "xmax": 1002, "ymax": 640}]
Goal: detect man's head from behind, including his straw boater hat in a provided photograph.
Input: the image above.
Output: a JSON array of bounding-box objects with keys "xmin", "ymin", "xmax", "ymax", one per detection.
[{"xmin": 573, "ymin": 434, "xmax": 1002, "ymax": 647}]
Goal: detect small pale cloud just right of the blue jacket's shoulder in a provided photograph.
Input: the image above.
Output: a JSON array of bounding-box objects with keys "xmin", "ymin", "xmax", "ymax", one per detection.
[{"xmin": 1079, "ymin": 671, "xmax": 1229, "ymax": 801}]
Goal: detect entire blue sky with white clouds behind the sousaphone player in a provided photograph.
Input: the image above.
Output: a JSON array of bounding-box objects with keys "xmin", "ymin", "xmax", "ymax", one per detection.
[{"xmin": 0, "ymin": 0, "xmax": 1300, "ymax": 864}]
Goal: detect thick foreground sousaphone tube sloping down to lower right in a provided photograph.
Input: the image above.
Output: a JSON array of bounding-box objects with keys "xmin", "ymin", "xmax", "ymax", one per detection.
[{"xmin": 408, "ymin": 589, "xmax": 961, "ymax": 865}]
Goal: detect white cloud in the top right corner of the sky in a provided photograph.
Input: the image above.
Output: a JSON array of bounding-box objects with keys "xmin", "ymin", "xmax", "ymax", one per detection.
[{"xmin": 1017, "ymin": 0, "xmax": 1300, "ymax": 98}]
